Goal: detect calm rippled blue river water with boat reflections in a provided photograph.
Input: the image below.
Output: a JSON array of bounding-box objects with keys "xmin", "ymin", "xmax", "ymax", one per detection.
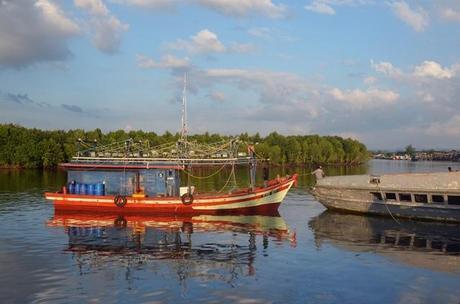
[{"xmin": 0, "ymin": 161, "xmax": 460, "ymax": 303}]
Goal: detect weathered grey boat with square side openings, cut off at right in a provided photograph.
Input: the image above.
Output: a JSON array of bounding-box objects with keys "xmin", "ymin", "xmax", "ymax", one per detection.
[{"xmin": 312, "ymin": 172, "xmax": 460, "ymax": 222}]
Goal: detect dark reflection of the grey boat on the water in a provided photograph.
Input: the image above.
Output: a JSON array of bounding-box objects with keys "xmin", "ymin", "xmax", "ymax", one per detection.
[{"xmin": 309, "ymin": 211, "xmax": 460, "ymax": 273}]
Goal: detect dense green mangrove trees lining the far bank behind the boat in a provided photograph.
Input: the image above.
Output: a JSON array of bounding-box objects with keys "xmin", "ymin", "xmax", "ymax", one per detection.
[{"xmin": 0, "ymin": 124, "xmax": 369, "ymax": 168}]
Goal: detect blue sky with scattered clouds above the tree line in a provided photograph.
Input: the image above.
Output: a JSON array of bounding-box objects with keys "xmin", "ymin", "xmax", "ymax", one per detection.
[{"xmin": 0, "ymin": 0, "xmax": 460, "ymax": 149}]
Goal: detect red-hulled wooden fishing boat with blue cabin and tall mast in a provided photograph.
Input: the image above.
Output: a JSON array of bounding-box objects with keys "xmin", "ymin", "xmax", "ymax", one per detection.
[{"xmin": 45, "ymin": 75, "xmax": 297, "ymax": 214}]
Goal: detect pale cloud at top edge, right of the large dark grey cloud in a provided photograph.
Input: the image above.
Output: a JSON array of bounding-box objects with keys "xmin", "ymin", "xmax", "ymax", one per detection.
[{"xmin": 74, "ymin": 0, "xmax": 129, "ymax": 54}]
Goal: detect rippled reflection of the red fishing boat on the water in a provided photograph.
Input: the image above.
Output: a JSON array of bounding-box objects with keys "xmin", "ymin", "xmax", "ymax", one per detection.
[{"xmin": 47, "ymin": 213, "xmax": 295, "ymax": 282}]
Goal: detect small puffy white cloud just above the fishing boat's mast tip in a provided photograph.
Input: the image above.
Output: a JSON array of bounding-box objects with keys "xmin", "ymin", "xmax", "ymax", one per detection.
[{"xmin": 168, "ymin": 29, "xmax": 254, "ymax": 54}]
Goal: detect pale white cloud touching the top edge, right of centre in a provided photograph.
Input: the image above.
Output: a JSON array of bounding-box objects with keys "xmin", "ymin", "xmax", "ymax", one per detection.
[{"xmin": 195, "ymin": 0, "xmax": 287, "ymax": 18}]
